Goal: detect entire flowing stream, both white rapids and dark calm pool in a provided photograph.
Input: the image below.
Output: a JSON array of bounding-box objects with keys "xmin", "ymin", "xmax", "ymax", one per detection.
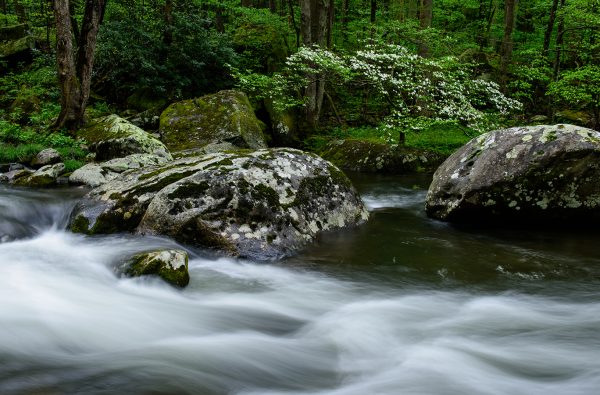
[{"xmin": 0, "ymin": 176, "xmax": 600, "ymax": 395}]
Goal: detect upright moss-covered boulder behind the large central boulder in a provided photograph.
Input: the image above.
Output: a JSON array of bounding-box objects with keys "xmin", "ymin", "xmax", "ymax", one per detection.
[{"xmin": 159, "ymin": 91, "xmax": 266, "ymax": 152}]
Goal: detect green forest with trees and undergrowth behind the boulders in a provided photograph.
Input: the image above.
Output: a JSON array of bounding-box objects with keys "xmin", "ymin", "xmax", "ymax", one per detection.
[{"xmin": 0, "ymin": 0, "xmax": 600, "ymax": 168}]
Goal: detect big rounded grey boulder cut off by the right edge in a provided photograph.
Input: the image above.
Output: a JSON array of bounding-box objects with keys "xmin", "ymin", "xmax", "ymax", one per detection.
[{"xmin": 426, "ymin": 125, "xmax": 600, "ymax": 225}]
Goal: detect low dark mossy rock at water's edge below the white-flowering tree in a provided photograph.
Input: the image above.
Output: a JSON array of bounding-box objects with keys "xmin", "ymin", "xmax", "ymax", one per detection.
[{"xmin": 320, "ymin": 139, "xmax": 444, "ymax": 174}]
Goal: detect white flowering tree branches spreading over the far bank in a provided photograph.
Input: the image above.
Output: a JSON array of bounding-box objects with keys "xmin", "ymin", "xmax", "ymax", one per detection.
[{"xmin": 238, "ymin": 44, "xmax": 521, "ymax": 142}]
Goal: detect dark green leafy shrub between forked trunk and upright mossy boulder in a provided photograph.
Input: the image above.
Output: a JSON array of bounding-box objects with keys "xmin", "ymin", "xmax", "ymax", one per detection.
[{"xmin": 94, "ymin": 12, "xmax": 237, "ymax": 103}]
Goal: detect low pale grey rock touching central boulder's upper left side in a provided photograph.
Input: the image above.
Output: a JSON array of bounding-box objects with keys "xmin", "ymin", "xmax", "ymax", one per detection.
[{"xmin": 69, "ymin": 154, "xmax": 168, "ymax": 188}]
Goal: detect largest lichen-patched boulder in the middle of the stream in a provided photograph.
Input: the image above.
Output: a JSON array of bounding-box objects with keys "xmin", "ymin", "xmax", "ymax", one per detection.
[{"xmin": 71, "ymin": 149, "xmax": 368, "ymax": 259}]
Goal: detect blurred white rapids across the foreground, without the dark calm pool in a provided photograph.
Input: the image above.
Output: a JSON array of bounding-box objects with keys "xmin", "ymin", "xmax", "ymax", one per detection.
[{"xmin": 0, "ymin": 184, "xmax": 600, "ymax": 395}]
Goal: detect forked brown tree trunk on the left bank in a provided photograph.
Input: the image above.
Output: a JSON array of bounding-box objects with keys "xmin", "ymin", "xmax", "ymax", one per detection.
[{"xmin": 54, "ymin": 0, "xmax": 106, "ymax": 130}]
